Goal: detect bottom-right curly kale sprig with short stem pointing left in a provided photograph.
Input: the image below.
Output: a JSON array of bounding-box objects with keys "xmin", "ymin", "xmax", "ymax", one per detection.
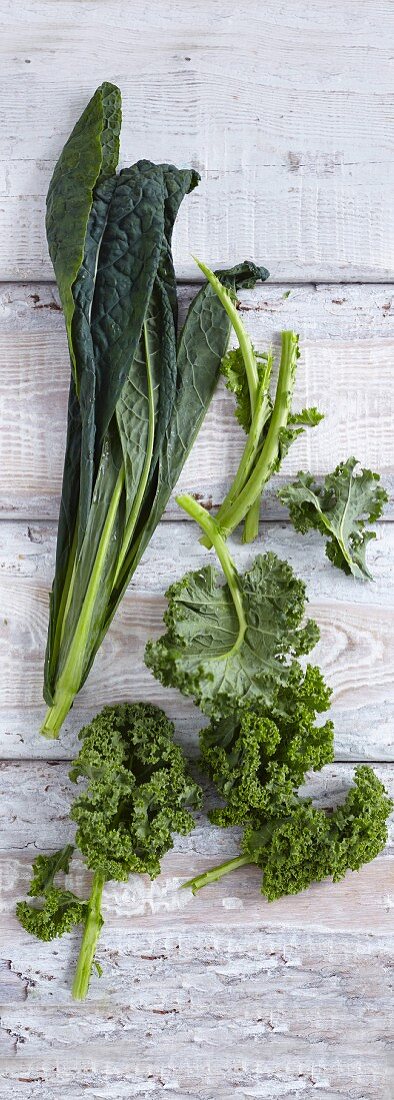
[{"xmin": 185, "ymin": 765, "xmax": 393, "ymax": 901}]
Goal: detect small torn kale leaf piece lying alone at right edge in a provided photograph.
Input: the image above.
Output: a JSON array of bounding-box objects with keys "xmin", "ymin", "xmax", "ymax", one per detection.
[{"xmin": 278, "ymin": 458, "xmax": 388, "ymax": 580}]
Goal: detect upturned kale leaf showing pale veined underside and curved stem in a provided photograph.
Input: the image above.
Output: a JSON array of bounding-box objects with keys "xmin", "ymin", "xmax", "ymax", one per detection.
[{"xmin": 145, "ymin": 496, "xmax": 319, "ymax": 718}]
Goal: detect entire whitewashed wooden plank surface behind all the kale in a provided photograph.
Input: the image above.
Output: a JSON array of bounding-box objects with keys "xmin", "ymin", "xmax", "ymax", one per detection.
[{"xmin": 0, "ymin": 0, "xmax": 394, "ymax": 1100}]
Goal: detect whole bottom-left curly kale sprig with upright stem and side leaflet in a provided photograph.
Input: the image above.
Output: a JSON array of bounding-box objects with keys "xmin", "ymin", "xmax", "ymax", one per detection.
[{"xmin": 17, "ymin": 703, "xmax": 201, "ymax": 1000}]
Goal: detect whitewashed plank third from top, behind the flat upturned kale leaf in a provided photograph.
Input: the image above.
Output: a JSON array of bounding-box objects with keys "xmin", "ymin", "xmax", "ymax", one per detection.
[{"xmin": 0, "ymin": 521, "xmax": 394, "ymax": 760}]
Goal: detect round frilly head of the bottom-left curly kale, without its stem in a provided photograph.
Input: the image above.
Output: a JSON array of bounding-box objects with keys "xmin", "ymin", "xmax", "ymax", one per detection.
[{"xmin": 70, "ymin": 703, "xmax": 201, "ymax": 880}]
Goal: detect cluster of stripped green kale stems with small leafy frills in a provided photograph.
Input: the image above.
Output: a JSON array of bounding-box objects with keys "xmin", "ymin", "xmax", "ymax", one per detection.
[{"xmin": 197, "ymin": 261, "xmax": 322, "ymax": 548}]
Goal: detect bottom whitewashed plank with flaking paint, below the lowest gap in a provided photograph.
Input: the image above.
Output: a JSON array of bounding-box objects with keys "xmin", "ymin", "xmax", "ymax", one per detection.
[{"xmin": 0, "ymin": 763, "xmax": 394, "ymax": 1100}]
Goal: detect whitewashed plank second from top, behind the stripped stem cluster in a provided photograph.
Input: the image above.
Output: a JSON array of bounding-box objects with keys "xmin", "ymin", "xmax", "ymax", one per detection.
[{"xmin": 0, "ymin": 284, "xmax": 394, "ymax": 518}]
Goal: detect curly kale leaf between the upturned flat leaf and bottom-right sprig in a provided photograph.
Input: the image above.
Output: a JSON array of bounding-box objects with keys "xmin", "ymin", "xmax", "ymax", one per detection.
[{"xmin": 200, "ymin": 666, "xmax": 333, "ymax": 826}]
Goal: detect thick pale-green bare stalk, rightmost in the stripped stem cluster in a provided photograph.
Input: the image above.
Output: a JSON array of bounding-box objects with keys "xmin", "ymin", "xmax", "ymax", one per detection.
[{"xmin": 213, "ymin": 332, "xmax": 298, "ymax": 538}]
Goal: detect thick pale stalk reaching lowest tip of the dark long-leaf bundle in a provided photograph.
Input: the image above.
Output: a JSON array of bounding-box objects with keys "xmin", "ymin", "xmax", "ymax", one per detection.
[{"xmin": 41, "ymin": 466, "xmax": 124, "ymax": 737}]
